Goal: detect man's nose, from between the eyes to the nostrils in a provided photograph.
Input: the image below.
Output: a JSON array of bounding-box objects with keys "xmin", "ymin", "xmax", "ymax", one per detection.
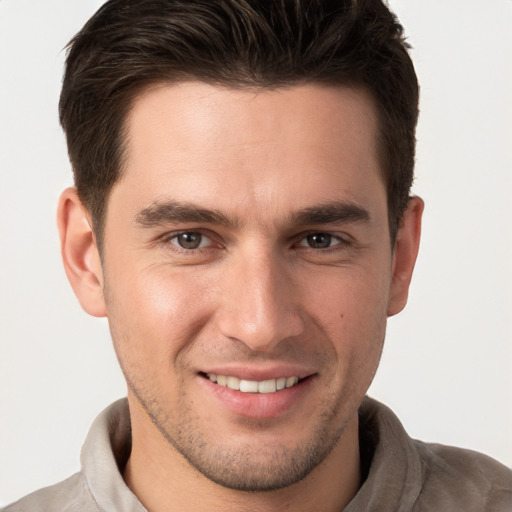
[{"xmin": 217, "ymin": 245, "xmax": 304, "ymax": 352}]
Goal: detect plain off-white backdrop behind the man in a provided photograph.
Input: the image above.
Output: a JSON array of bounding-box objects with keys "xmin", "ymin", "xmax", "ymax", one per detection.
[{"xmin": 0, "ymin": 0, "xmax": 512, "ymax": 506}]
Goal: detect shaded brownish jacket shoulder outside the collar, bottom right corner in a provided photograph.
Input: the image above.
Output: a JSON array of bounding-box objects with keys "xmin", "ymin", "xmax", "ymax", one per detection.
[{"xmin": 415, "ymin": 441, "xmax": 512, "ymax": 512}]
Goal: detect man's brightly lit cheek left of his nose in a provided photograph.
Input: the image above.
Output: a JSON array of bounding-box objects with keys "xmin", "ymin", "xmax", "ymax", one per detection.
[{"xmin": 106, "ymin": 267, "xmax": 216, "ymax": 372}]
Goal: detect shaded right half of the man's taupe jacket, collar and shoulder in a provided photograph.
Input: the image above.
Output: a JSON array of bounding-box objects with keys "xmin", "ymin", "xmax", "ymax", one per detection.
[{"xmin": 352, "ymin": 398, "xmax": 512, "ymax": 512}]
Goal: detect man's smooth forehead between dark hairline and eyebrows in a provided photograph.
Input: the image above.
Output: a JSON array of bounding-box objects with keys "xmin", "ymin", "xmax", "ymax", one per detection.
[{"xmin": 114, "ymin": 82, "xmax": 384, "ymax": 226}]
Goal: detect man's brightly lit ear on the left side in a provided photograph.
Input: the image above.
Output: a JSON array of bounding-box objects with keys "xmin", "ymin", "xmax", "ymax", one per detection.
[{"xmin": 57, "ymin": 188, "xmax": 106, "ymax": 316}]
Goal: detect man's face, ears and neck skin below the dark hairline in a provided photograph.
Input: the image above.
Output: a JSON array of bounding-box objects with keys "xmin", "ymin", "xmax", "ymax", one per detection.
[{"xmin": 58, "ymin": 82, "xmax": 423, "ymax": 511}]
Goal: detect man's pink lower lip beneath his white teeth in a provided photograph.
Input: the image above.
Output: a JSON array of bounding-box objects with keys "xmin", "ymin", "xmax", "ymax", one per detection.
[{"xmin": 199, "ymin": 376, "xmax": 313, "ymax": 419}]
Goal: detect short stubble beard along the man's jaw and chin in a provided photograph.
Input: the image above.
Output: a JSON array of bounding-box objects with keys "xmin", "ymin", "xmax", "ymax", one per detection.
[{"xmin": 109, "ymin": 300, "xmax": 358, "ymax": 492}]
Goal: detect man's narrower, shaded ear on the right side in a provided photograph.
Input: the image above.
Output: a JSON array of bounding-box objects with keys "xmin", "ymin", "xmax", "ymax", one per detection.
[{"xmin": 388, "ymin": 196, "xmax": 425, "ymax": 316}]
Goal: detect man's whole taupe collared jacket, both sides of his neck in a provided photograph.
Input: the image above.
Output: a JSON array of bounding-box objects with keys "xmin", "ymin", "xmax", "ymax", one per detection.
[{"xmin": 4, "ymin": 398, "xmax": 512, "ymax": 512}]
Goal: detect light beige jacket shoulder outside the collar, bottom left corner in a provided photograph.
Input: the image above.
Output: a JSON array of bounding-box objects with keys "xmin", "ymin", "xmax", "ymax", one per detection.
[{"xmin": 3, "ymin": 473, "xmax": 99, "ymax": 512}]
